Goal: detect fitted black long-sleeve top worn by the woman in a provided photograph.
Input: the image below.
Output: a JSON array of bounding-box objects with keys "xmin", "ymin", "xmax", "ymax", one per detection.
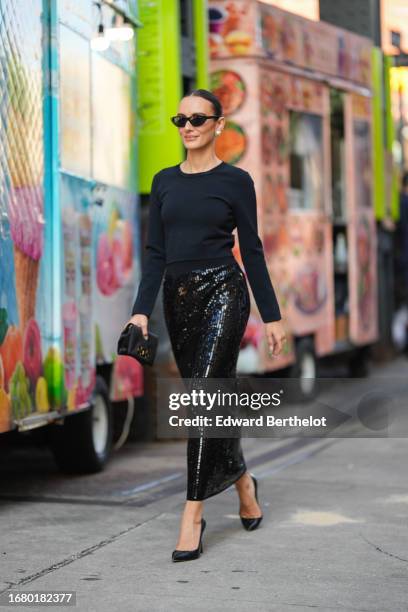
[{"xmin": 132, "ymin": 162, "xmax": 281, "ymax": 323}]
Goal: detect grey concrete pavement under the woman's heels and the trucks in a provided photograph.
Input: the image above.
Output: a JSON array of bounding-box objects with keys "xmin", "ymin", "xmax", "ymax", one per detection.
[{"xmin": 0, "ymin": 358, "xmax": 408, "ymax": 612}]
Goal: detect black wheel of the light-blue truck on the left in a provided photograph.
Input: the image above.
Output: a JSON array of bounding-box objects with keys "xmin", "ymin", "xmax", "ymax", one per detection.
[{"xmin": 49, "ymin": 376, "xmax": 113, "ymax": 474}]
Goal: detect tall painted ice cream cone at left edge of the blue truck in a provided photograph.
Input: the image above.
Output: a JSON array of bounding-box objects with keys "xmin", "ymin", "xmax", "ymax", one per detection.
[{"xmin": 4, "ymin": 51, "xmax": 44, "ymax": 332}]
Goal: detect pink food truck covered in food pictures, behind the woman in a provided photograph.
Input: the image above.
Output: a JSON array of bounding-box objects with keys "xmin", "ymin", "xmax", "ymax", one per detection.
[{"xmin": 208, "ymin": 0, "xmax": 396, "ymax": 399}]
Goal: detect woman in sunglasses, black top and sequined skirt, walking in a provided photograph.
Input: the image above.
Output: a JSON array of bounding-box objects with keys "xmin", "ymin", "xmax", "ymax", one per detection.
[{"xmin": 124, "ymin": 89, "xmax": 285, "ymax": 561}]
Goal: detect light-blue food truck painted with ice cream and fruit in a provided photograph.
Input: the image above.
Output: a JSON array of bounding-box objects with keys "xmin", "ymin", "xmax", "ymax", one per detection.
[{"xmin": 0, "ymin": 0, "xmax": 143, "ymax": 470}]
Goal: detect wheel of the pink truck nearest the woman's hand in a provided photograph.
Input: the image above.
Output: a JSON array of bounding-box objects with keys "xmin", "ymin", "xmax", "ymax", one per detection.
[{"xmin": 288, "ymin": 338, "xmax": 317, "ymax": 402}]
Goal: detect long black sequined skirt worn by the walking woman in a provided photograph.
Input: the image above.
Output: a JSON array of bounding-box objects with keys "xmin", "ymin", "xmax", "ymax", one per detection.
[{"xmin": 163, "ymin": 258, "xmax": 250, "ymax": 501}]
